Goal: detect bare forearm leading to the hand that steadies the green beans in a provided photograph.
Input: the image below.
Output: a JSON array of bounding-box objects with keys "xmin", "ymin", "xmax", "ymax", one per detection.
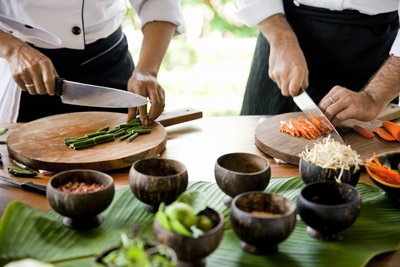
[{"xmin": 135, "ymin": 21, "xmax": 176, "ymax": 76}]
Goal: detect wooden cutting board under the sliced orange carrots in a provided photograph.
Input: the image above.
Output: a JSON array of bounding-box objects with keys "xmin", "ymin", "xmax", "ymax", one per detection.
[{"xmin": 255, "ymin": 112, "xmax": 400, "ymax": 165}]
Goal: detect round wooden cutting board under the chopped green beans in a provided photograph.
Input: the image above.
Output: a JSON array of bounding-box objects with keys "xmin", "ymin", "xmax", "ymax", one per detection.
[{"xmin": 7, "ymin": 112, "xmax": 167, "ymax": 171}]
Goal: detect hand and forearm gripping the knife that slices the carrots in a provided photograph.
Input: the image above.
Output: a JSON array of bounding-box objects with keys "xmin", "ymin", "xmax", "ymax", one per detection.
[{"xmin": 259, "ymin": 14, "xmax": 308, "ymax": 96}]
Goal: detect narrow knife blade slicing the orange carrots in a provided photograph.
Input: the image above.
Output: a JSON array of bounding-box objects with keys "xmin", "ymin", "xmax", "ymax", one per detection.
[{"xmin": 293, "ymin": 89, "xmax": 345, "ymax": 144}]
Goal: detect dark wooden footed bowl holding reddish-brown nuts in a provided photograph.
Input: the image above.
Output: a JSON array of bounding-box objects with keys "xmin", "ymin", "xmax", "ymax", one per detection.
[{"xmin": 47, "ymin": 169, "xmax": 115, "ymax": 230}]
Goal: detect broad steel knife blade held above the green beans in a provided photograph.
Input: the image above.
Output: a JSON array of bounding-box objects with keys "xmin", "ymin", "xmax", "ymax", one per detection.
[{"xmin": 56, "ymin": 77, "xmax": 148, "ymax": 108}]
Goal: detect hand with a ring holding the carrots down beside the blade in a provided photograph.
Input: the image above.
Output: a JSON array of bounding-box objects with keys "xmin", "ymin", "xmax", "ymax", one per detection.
[{"xmin": 319, "ymin": 86, "xmax": 386, "ymax": 125}]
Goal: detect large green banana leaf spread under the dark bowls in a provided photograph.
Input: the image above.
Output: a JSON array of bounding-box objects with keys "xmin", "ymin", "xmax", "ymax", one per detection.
[{"xmin": 0, "ymin": 177, "xmax": 400, "ymax": 267}]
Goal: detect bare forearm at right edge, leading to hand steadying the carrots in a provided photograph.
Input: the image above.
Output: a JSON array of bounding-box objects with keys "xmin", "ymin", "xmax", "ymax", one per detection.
[{"xmin": 364, "ymin": 55, "xmax": 400, "ymax": 109}]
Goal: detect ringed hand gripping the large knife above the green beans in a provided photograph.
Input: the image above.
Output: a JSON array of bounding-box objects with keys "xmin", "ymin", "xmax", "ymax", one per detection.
[{"xmin": 0, "ymin": 32, "xmax": 58, "ymax": 95}]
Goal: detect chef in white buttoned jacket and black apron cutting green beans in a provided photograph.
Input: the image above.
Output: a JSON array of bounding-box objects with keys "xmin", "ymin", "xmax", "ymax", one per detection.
[{"xmin": 0, "ymin": 0, "xmax": 184, "ymax": 124}]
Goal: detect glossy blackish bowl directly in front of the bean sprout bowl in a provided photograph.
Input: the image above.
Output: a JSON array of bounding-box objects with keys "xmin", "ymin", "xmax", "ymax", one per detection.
[{"xmin": 297, "ymin": 181, "xmax": 361, "ymax": 241}]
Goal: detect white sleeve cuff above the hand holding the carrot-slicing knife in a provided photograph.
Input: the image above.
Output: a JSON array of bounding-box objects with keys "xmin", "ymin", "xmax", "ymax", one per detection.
[{"xmin": 236, "ymin": 0, "xmax": 284, "ymax": 26}]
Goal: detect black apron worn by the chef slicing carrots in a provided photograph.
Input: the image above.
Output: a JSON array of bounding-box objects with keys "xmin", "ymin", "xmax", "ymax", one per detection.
[{"xmin": 241, "ymin": 0, "xmax": 399, "ymax": 115}]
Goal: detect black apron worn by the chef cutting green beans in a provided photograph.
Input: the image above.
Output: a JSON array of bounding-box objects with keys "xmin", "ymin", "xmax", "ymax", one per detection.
[{"xmin": 17, "ymin": 28, "xmax": 134, "ymax": 122}]
